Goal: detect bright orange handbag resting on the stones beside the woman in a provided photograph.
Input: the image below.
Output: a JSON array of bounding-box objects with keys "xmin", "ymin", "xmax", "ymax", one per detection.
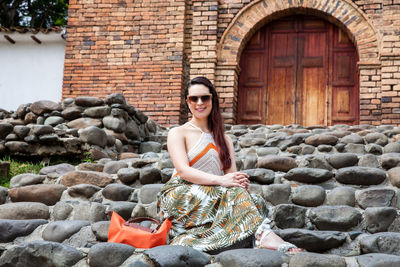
[{"xmin": 108, "ymin": 212, "xmax": 172, "ymax": 248}]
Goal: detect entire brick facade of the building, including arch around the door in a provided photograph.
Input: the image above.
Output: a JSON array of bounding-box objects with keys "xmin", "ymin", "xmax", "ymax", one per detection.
[{"xmin": 63, "ymin": 0, "xmax": 400, "ymax": 125}]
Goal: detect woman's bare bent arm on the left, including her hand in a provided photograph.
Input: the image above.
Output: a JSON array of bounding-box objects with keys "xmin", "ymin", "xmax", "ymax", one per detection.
[{"xmin": 167, "ymin": 127, "xmax": 247, "ymax": 188}]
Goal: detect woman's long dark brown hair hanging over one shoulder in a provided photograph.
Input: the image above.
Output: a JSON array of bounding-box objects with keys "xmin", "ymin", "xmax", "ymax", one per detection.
[{"xmin": 185, "ymin": 77, "xmax": 232, "ymax": 171}]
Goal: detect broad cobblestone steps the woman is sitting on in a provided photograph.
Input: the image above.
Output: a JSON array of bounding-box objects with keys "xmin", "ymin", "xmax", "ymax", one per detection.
[{"xmin": 0, "ymin": 125, "xmax": 400, "ymax": 267}]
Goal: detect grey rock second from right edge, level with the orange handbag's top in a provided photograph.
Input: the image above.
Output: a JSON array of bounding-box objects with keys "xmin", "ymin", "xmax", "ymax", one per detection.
[{"xmin": 309, "ymin": 206, "xmax": 362, "ymax": 231}]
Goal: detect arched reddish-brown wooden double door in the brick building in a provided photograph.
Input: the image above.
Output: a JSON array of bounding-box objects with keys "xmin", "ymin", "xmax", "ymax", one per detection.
[{"xmin": 238, "ymin": 16, "xmax": 359, "ymax": 126}]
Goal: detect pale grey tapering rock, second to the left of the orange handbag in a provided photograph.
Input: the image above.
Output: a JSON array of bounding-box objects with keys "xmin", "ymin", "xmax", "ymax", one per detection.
[{"xmin": 42, "ymin": 220, "xmax": 90, "ymax": 243}]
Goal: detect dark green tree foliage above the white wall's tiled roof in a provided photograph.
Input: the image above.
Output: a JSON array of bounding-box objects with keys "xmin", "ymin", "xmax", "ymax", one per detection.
[{"xmin": 0, "ymin": 0, "xmax": 69, "ymax": 28}]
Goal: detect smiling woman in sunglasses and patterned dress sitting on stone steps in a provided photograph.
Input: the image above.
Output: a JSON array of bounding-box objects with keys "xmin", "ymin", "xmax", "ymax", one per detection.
[{"xmin": 159, "ymin": 77, "xmax": 298, "ymax": 252}]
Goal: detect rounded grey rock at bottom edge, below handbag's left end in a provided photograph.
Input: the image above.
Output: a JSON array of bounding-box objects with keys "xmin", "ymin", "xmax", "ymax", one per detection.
[{"xmin": 88, "ymin": 243, "xmax": 135, "ymax": 267}]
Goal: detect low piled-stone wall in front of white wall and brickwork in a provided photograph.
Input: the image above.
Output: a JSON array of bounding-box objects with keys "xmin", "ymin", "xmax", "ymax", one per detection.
[{"xmin": 0, "ymin": 93, "xmax": 159, "ymax": 158}]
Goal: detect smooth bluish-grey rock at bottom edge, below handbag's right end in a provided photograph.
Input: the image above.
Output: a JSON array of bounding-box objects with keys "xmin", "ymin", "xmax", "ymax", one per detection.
[{"xmin": 143, "ymin": 245, "xmax": 210, "ymax": 267}]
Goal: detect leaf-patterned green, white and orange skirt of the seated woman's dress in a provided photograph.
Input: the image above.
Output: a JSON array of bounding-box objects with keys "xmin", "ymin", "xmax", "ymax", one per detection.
[{"xmin": 159, "ymin": 176, "xmax": 268, "ymax": 251}]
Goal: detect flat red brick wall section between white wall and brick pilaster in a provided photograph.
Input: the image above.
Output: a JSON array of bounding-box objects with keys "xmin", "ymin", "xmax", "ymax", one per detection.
[{"xmin": 63, "ymin": 0, "xmax": 185, "ymax": 124}]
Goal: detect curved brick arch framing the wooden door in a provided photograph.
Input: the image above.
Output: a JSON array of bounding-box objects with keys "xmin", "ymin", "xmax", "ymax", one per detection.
[{"xmin": 215, "ymin": 0, "xmax": 381, "ymax": 123}]
